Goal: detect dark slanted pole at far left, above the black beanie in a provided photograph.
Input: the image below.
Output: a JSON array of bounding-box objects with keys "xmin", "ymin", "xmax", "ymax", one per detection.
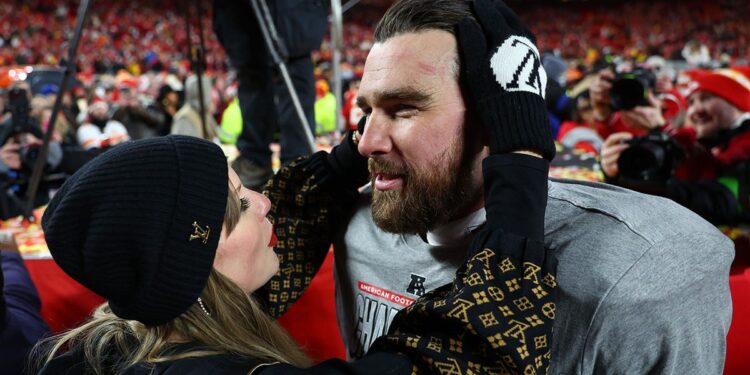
[{"xmin": 23, "ymin": 0, "xmax": 91, "ymax": 222}]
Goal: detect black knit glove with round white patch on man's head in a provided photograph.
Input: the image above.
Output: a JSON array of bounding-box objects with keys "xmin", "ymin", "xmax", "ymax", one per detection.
[{"xmin": 456, "ymin": 0, "xmax": 555, "ymax": 160}]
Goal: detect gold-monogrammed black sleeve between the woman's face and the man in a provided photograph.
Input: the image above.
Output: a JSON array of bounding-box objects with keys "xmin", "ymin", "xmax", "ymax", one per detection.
[{"xmin": 255, "ymin": 131, "xmax": 367, "ymax": 318}]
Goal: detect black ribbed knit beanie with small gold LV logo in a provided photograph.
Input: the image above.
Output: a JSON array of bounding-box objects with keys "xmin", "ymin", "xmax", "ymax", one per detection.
[{"xmin": 42, "ymin": 136, "xmax": 229, "ymax": 325}]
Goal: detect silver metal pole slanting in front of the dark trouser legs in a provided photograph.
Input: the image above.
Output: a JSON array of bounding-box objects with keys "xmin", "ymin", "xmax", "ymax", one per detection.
[{"xmin": 250, "ymin": 0, "xmax": 317, "ymax": 152}]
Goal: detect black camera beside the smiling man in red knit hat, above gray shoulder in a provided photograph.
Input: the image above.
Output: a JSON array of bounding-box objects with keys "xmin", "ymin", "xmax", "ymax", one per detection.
[{"xmin": 617, "ymin": 131, "xmax": 685, "ymax": 182}]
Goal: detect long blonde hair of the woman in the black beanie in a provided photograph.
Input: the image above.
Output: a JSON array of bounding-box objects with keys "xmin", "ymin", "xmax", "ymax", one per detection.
[{"xmin": 32, "ymin": 186, "xmax": 311, "ymax": 374}]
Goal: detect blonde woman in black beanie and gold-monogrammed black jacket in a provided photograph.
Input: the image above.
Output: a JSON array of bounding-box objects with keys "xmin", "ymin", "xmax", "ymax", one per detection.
[{"xmin": 33, "ymin": 131, "xmax": 554, "ymax": 375}]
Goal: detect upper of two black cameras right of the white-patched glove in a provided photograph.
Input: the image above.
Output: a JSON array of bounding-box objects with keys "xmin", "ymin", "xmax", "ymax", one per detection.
[{"xmin": 609, "ymin": 67, "xmax": 656, "ymax": 111}]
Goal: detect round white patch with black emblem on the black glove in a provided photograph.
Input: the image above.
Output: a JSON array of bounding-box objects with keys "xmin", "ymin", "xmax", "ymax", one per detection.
[{"xmin": 490, "ymin": 35, "xmax": 547, "ymax": 98}]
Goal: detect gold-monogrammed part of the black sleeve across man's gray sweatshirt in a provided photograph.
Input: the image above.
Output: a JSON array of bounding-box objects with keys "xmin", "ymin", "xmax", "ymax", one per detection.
[{"xmin": 370, "ymin": 239, "xmax": 557, "ymax": 375}]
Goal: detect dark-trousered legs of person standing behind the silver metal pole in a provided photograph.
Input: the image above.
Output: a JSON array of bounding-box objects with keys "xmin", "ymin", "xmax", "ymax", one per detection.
[{"xmin": 213, "ymin": 0, "xmax": 328, "ymax": 178}]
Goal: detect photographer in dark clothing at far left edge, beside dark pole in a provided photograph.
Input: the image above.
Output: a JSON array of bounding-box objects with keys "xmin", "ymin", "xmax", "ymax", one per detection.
[{"xmin": 0, "ymin": 83, "xmax": 63, "ymax": 220}]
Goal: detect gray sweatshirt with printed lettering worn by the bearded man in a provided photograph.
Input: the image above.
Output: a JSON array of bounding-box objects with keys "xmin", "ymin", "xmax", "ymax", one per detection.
[{"xmin": 335, "ymin": 180, "xmax": 734, "ymax": 375}]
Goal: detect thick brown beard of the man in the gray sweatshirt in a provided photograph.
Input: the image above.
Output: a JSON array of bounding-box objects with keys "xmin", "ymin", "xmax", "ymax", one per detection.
[{"xmin": 369, "ymin": 141, "xmax": 477, "ymax": 234}]
